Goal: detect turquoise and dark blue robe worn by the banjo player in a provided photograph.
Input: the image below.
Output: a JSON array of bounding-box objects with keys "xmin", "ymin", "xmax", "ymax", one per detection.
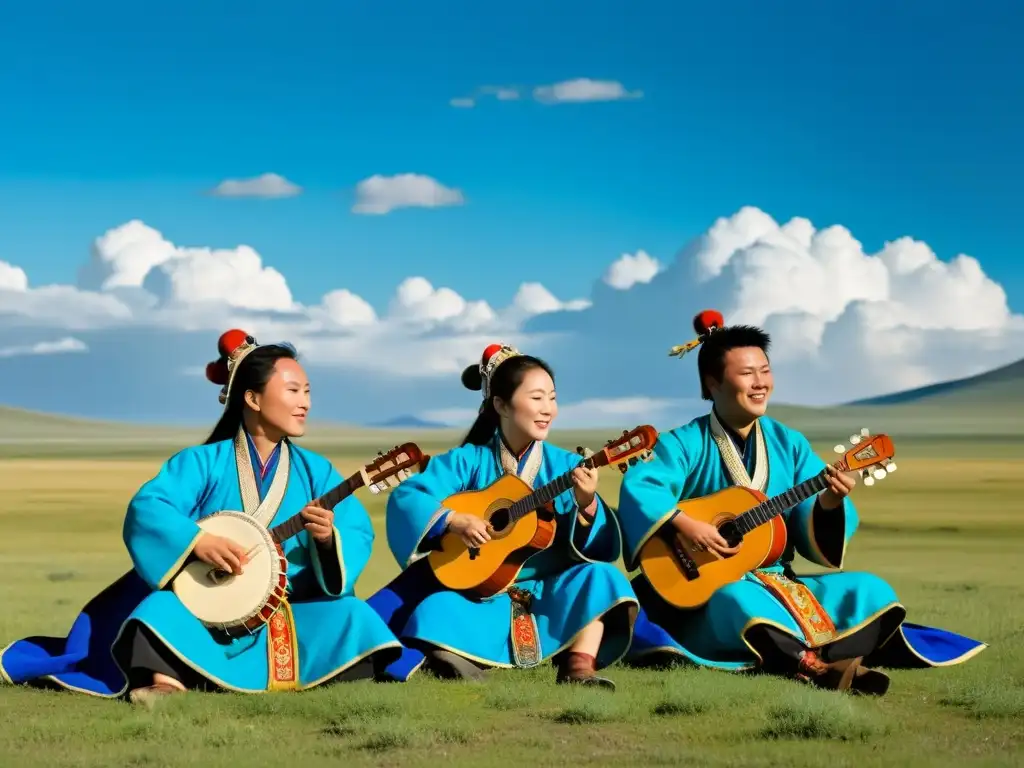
[{"xmin": 0, "ymin": 431, "xmax": 401, "ymax": 696}]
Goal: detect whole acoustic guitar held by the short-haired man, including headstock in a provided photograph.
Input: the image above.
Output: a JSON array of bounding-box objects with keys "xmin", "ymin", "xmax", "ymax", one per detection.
[{"xmin": 639, "ymin": 429, "xmax": 896, "ymax": 608}]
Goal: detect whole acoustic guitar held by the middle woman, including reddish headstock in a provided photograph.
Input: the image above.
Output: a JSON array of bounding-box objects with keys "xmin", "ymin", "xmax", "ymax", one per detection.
[{"xmin": 427, "ymin": 425, "xmax": 657, "ymax": 598}]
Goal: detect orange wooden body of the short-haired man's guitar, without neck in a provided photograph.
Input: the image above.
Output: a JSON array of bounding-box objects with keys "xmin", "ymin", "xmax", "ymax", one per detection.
[{"xmin": 639, "ymin": 486, "xmax": 786, "ymax": 608}]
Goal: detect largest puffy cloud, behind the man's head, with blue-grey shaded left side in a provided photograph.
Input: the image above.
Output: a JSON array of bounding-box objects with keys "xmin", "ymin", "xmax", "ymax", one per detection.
[{"xmin": 525, "ymin": 207, "xmax": 1024, "ymax": 404}]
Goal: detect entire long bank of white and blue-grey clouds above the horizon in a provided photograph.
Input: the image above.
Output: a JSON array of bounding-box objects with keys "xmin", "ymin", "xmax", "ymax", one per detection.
[{"xmin": 0, "ymin": 208, "xmax": 1024, "ymax": 428}]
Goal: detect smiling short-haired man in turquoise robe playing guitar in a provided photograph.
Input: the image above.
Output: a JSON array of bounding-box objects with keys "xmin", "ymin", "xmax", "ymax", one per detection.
[{"xmin": 617, "ymin": 310, "xmax": 986, "ymax": 695}]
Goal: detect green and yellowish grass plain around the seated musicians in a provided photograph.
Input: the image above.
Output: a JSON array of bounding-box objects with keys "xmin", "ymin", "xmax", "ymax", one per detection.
[{"xmin": 0, "ymin": 430, "xmax": 1024, "ymax": 768}]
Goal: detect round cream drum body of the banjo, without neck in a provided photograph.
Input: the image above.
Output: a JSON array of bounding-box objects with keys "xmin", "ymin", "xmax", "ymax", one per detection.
[{"xmin": 171, "ymin": 511, "xmax": 288, "ymax": 637}]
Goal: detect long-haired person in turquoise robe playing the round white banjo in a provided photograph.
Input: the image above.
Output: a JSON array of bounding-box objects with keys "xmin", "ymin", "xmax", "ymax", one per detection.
[{"xmin": 0, "ymin": 331, "xmax": 401, "ymax": 705}]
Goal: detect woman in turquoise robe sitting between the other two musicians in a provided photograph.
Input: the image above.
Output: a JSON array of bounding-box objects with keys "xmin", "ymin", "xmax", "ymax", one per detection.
[{"xmin": 370, "ymin": 344, "xmax": 637, "ymax": 689}]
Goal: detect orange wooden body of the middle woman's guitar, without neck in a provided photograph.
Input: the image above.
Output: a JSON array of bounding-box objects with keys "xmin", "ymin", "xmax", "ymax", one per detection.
[{"xmin": 427, "ymin": 475, "xmax": 555, "ymax": 597}]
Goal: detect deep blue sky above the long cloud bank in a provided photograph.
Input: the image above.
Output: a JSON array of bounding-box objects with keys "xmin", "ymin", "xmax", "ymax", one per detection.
[{"xmin": 0, "ymin": 0, "xmax": 1024, "ymax": 428}]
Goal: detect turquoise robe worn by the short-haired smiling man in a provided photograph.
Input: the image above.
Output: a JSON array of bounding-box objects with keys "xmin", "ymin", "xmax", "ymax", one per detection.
[{"xmin": 618, "ymin": 412, "xmax": 986, "ymax": 670}]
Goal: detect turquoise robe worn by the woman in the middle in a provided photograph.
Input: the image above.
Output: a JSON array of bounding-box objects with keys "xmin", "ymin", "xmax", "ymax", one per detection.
[{"xmin": 369, "ymin": 433, "xmax": 638, "ymax": 679}]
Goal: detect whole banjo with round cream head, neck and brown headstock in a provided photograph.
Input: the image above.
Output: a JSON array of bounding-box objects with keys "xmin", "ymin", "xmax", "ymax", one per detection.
[{"xmin": 170, "ymin": 442, "xmax": 429, "ymax": 637}]
